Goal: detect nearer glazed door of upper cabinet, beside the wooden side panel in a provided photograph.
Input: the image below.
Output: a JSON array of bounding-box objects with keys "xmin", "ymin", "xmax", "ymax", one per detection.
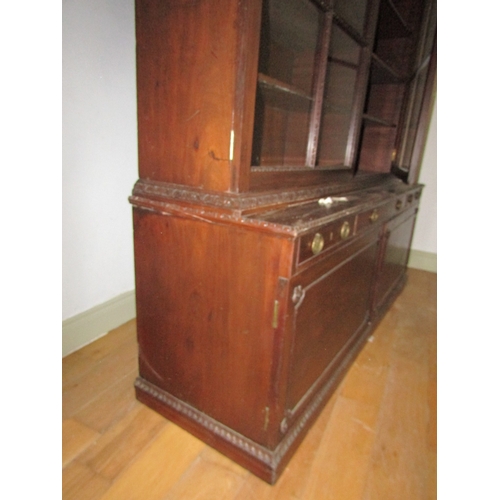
[{"xmin": 252, "ymin": 0, "xmax": 371, "ymax": 171}]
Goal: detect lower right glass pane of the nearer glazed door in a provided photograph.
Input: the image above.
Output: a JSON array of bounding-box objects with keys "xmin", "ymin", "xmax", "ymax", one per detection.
[{"xmin": 317, "ymin": 63, "xmax": 357, "ymax": 167}]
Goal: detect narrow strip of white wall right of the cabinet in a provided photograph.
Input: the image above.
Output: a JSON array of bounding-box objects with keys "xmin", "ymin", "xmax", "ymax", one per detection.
[{"xmin": 412, "ymin": 98, "xmax": 437, "ymax": 255}]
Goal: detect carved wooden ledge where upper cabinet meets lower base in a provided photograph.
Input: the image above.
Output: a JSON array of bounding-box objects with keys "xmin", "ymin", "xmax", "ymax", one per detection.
[{"xmin": 130, "ymin": 178, "xmax": 423, "ymax": 236}]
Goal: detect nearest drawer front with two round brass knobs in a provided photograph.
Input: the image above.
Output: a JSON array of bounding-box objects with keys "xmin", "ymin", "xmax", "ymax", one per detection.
[{"xmin": 299, "ymin": 215, "xmax": 356, "ymax": 263}]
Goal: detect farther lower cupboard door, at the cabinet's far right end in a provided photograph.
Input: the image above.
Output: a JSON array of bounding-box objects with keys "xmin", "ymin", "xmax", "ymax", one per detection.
[{"xmin": 375, "ymin": 210, "xmax": 416, "ymax": 308}]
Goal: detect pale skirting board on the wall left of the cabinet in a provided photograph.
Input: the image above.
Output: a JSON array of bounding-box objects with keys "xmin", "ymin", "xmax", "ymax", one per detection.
[{"xmin": 62, "ymin": 290, "xmax": 136, "ymax": 358}]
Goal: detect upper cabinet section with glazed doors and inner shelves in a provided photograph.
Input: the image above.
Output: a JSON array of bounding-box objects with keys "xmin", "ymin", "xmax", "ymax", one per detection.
[{"xmin": 136, "ymin": 0, "xmax": 435, "ymax": 193}]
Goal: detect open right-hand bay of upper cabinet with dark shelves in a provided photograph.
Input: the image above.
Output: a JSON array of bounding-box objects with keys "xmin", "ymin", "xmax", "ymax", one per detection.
[{"xmin": 357, "ymin": 0, "xmax": 436, "ymax": 178}]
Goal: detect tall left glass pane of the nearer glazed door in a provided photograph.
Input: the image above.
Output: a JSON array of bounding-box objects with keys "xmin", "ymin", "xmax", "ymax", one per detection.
[{"xmin": 252, "ymin": 0, "xmax": 323, "ymax": 167}]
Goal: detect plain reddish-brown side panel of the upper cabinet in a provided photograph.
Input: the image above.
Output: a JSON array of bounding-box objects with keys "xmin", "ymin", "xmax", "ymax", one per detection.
[{"xmin": 136, "ymin": 0, "xmax": 238, "ymax": 191}]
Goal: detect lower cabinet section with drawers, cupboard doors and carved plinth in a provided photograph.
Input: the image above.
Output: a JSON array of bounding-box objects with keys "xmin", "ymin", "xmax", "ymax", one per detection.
[{"xmin": 131, "ymin": 182, "xmax": 421, "ymax": 484}]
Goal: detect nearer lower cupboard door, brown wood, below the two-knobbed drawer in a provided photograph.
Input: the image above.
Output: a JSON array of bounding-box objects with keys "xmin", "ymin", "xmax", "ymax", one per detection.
[{"xmin": 287, "ymin": 238, "xmax": 377, "ymax": 413}]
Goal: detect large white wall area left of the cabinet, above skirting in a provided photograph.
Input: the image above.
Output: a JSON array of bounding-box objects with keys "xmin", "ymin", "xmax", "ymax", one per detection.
[{"xmin": 62, "ymin": 0, "xmax": 138, "ymax": 320}]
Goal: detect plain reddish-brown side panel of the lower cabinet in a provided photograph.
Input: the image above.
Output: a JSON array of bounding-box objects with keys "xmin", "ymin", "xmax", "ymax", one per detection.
[{"xmin": 134, "ymin": 209, "xmax": 290, "ymax": 445}]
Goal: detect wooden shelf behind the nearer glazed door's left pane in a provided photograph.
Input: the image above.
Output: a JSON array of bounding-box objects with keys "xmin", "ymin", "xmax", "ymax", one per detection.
[{"xmin": 258, "ymin": 73, "xmax": 313, "ymax": 111}]
